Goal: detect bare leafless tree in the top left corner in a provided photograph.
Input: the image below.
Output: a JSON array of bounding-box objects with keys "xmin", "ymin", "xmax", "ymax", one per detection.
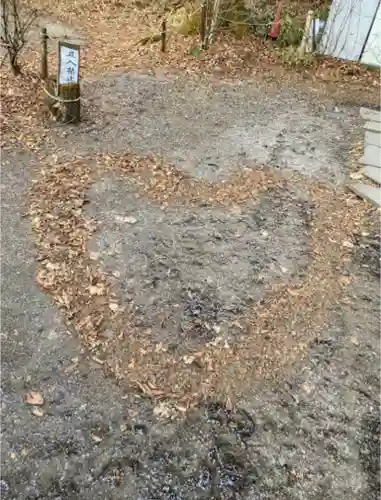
[{"xmin": 0, "ymin": 0, "xmax": 37, "ymax": 75}]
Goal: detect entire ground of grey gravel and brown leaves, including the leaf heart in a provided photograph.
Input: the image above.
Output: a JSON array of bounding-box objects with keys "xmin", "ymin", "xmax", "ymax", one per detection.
[{"xmin": 0, "ymin": 2, "xmax": 380, "ymax": 500}]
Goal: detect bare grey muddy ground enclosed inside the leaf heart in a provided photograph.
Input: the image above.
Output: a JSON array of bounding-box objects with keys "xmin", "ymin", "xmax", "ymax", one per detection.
[{"xmin": 89, "ymin": 178, "xmax": 309, "ymax": 343}]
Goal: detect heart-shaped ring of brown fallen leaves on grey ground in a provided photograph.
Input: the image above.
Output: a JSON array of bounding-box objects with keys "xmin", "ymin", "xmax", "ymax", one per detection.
[{"xmin": 29, "ymin": 155, "xmax": 367, "ymax": 411}]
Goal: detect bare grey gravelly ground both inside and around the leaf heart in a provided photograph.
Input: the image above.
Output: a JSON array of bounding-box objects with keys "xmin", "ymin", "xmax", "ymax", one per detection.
[{"xmin": 0, "ymin": 37, "xmax": 380, "ymax": 500}]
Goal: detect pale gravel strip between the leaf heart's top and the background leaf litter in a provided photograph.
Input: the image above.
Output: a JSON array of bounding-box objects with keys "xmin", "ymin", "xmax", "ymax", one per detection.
[{"xmin": 47, "ymin": 74, "xmax": 359, "ymax": 184}]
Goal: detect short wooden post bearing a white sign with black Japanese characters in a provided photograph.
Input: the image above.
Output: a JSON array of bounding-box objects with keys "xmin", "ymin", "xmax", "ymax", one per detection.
[{"xmin": 57, "ymin": 42, "xmax": 81, "ymax": 123}]
